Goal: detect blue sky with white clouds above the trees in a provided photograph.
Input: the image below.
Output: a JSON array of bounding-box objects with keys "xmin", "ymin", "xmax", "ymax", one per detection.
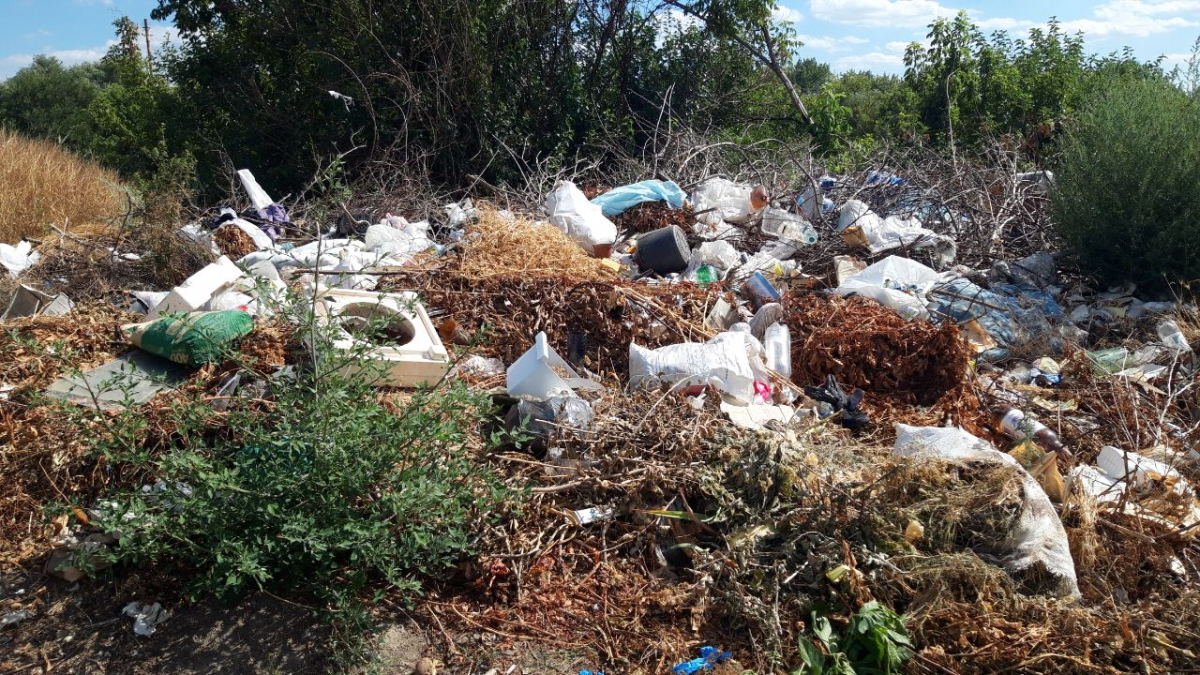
[{"xmin": 0, "ymin": 0, "xmax": 1200, "ymax": 78}]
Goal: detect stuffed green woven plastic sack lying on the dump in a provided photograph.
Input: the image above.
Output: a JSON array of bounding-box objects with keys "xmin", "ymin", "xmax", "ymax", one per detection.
[{"xmin": 121, "ymin": 310, "xmax": 254, "ymax": 365}]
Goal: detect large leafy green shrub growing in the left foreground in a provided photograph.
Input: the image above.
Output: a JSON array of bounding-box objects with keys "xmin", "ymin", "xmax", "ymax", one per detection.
[{"xmin": 65, "ymin": 284, "xmax": 509, "ymax": 646}]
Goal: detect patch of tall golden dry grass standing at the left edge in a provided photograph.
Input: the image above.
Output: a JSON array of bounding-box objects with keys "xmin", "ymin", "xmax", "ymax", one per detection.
[{"xmin": 0, "ymin": 130, "xmax": 121, "ymax": 244}]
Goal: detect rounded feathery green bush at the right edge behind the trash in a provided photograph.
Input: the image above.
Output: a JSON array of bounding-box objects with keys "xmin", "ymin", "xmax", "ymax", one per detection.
[{"xmin": 1052, "ymin": 78, "xmax": 1200, "ymax": 291}]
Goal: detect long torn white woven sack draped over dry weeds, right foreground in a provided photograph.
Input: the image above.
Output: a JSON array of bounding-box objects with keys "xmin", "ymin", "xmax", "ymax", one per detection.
[{"xmin": 892, "ymin": 424, "xmax": 1080, "ymax": 597}]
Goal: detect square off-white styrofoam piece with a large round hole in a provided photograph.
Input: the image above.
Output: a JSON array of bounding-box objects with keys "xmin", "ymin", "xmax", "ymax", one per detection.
[{"xmin": 317, "ymin": 288, "xmax": 450, "ymax": 387}]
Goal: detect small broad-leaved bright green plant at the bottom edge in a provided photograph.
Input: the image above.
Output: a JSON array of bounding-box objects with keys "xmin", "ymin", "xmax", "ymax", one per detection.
[{"xmin": 793, "ymin": 601, "xmax": 912, "ymax": 675}]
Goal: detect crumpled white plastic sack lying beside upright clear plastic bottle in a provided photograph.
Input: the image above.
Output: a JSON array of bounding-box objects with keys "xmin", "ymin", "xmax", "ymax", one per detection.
[{"xmin": 629, "ymin": 331, "xmax": 768, "ymax": 402}]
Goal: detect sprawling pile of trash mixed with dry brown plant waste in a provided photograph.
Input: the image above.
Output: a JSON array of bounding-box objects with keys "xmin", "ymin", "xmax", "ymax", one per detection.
[{"xmin": 0, "ymin": 164, "xmax": 1200, "ymax": 673}]
